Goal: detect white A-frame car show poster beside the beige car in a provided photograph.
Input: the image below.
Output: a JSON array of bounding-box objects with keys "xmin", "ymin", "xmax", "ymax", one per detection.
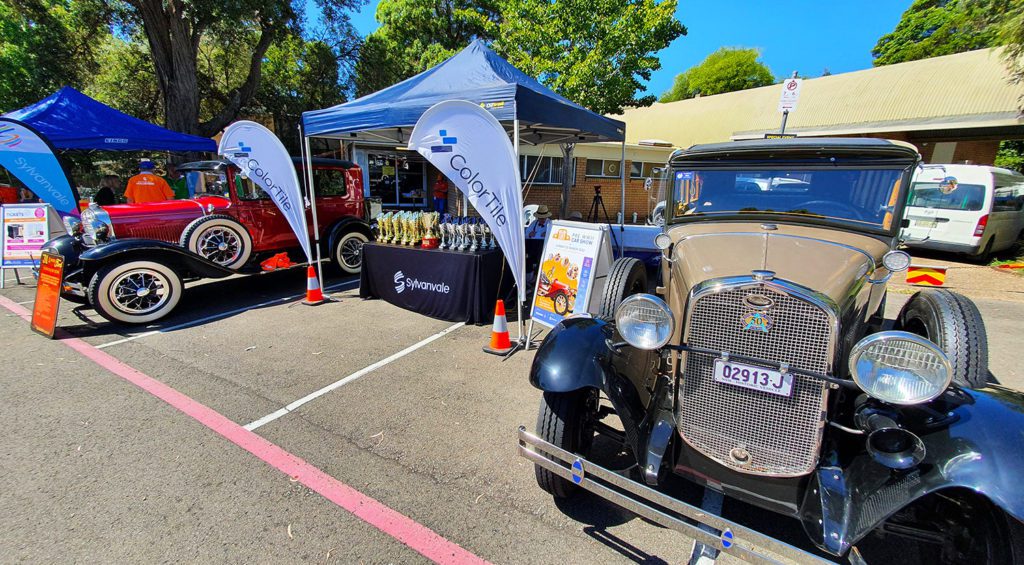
[{"xmin": 531, "ymin": 221, "xmax": 610, "ymax": 328}]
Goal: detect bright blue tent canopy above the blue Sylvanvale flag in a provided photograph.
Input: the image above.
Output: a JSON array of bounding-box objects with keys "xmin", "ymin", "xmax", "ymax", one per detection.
[{"xmin": 4, "ymin": 86, "xmax": 217, "ymax": 151}]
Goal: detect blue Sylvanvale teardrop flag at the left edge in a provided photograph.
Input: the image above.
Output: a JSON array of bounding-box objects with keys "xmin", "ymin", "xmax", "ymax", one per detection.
[{"xmin": 0, "ymin": 118, "xmax": 80, "ymax": 217}]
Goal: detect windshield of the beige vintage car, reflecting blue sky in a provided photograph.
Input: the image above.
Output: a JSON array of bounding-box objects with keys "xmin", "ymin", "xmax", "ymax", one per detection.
[{"xmin": 672, "ymin": 169, "xmax": 903, "ymax": 230}]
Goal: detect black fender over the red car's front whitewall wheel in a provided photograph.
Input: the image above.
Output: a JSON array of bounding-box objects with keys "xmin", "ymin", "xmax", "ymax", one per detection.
[{"xmin": 79, "ymin": 238, "xmax": 238, "ymax": 284}]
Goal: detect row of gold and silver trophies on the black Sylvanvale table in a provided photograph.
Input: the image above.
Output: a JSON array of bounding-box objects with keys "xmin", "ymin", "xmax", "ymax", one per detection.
[{"xmin": 377, "ymin": 211, "xmax": 498, "ymax": 253}]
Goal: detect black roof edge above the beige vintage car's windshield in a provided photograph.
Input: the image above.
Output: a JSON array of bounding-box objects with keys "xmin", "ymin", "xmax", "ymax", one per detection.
[{"xmin": 669, "ymin": 137, "xmax": 921, "ymax": 164}]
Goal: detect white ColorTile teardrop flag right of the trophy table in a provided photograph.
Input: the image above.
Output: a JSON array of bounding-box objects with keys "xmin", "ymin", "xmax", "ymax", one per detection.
[{"xmin": 409, "ymin": 100, "xmax": 526, "ymax": 303}]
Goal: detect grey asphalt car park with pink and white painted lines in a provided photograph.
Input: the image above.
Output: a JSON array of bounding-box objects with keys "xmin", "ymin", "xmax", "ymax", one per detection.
[{"xmin": 0, "ymin": 258, "xmax": 1024, "ymax": 563}]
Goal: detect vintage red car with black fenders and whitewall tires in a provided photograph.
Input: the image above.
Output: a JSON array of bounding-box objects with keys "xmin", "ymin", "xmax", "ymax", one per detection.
[{"xmin": 46, "ymin": 159, "xmax": 372, "ymax": 323}]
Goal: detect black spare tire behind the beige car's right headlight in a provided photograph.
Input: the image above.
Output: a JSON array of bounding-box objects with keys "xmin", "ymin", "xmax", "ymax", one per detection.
[{"xmin": 897, "ymin": 289, "xmax": 988, "ymax": 389}]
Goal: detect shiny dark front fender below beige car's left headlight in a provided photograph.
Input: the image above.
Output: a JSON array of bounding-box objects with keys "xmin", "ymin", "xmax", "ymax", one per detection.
[{"xmin": 529, "ymin": 317, "xmax": 657, "ymax": 453}]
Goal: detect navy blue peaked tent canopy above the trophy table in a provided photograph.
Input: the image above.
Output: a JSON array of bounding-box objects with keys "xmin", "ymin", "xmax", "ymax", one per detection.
[{"xmin": 302, "ymin": 40, "xmax": 625, "ymax": 144}]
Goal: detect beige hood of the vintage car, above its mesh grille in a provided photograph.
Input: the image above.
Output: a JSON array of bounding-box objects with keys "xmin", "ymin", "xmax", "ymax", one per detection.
[{"xmin": 669, "ymin": 222, "xmax": 890, "ymax": 306}]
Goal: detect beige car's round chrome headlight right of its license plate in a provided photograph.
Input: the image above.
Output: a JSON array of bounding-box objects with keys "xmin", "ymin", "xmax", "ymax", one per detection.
[{"xmin": 850, "ymin": 332, "xmax": 953, "ymax": 404}]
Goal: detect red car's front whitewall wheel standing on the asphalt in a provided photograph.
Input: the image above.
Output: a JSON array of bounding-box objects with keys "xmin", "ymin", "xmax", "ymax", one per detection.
[{"xmin": 86, "ymin": 261, "xmax": 182, "ymax": 323}]
